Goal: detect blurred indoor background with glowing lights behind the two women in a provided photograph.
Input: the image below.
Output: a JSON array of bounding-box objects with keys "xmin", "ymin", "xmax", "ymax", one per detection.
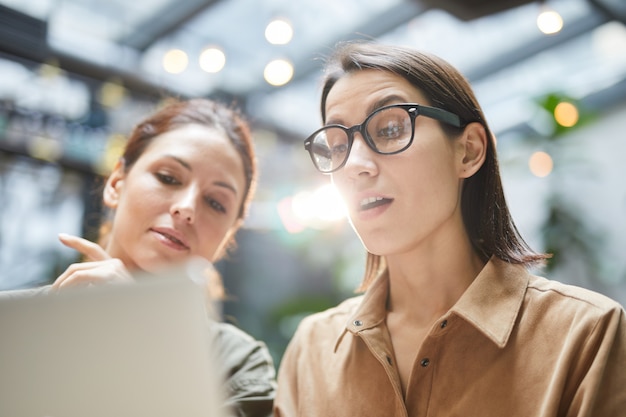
[{"xmin": 0, "ymin": 0, "xmax": 626, "ymax": 365}]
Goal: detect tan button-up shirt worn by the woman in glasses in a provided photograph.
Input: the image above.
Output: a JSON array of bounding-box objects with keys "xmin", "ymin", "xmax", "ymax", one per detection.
[{"xmin": 274, "ymin": 259, "xmax": 626, "ymax": 417}]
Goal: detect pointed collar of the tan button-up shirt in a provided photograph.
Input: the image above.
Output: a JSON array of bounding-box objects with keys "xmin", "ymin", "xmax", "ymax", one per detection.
[{"xmin": 335, "ymin": 256, "xmax": 529, "ymax": 351}]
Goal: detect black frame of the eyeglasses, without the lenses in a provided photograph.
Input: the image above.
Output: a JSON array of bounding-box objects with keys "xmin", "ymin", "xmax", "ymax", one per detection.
[{"xmin": 304, "ymin": 103, "xmax": 466, "ymax": 174}]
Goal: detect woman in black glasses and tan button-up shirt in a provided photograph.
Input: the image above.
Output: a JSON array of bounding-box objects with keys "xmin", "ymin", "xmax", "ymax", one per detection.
[{"xmin": 274, "ymin": 43, "xmax": 626, "ymax": 417}]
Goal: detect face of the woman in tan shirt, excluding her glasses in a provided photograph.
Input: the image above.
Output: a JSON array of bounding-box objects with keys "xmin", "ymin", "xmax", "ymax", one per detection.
[{"xmin": 326, "ymin": 70, "xmax": 464, "ymax": 256}]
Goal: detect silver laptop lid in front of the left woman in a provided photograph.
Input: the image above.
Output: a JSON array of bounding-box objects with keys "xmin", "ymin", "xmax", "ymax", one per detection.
[{"xmin": 0, "ymin": 262, "xmax": 223, "ymax": 417}]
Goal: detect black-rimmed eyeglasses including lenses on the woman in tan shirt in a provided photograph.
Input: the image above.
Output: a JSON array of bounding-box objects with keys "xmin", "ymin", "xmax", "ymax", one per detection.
[{"xmin": 304, "ymin": 104, "xmax": 463, "ymax": 174}]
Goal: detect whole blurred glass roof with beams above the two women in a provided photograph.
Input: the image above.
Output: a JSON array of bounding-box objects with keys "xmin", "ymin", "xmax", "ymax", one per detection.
[{"xmin": 0, "ymin": 0, "xmax": 626, "ymax": 144}]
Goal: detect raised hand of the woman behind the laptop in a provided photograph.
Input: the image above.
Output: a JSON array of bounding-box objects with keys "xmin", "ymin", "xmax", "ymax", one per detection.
[{"xmin": 52, "ymin": 233, "xmax": 133, "ymax": 289}]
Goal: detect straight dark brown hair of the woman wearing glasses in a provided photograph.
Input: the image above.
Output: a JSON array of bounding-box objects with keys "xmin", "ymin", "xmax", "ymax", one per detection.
[{"xmin": 321, "ymin": 42, "xmax": 549, "ymax": 291}]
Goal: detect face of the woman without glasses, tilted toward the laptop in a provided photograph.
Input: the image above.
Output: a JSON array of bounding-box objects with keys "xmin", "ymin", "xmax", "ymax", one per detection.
[{"xmin": 104, "ymin": 125, "xmax": 246, "ymax": 271}]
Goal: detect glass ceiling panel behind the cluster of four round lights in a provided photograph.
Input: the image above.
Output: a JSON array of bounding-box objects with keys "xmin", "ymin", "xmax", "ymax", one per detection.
[{"xmin": 142, "ymin": 0, "xmax": 411, "ymax": 94}]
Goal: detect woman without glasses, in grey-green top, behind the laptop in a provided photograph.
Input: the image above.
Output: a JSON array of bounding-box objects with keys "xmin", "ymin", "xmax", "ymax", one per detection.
[{"xmin": 3, "ymin": 99, "xmax": 275, "ymax": 417}]
